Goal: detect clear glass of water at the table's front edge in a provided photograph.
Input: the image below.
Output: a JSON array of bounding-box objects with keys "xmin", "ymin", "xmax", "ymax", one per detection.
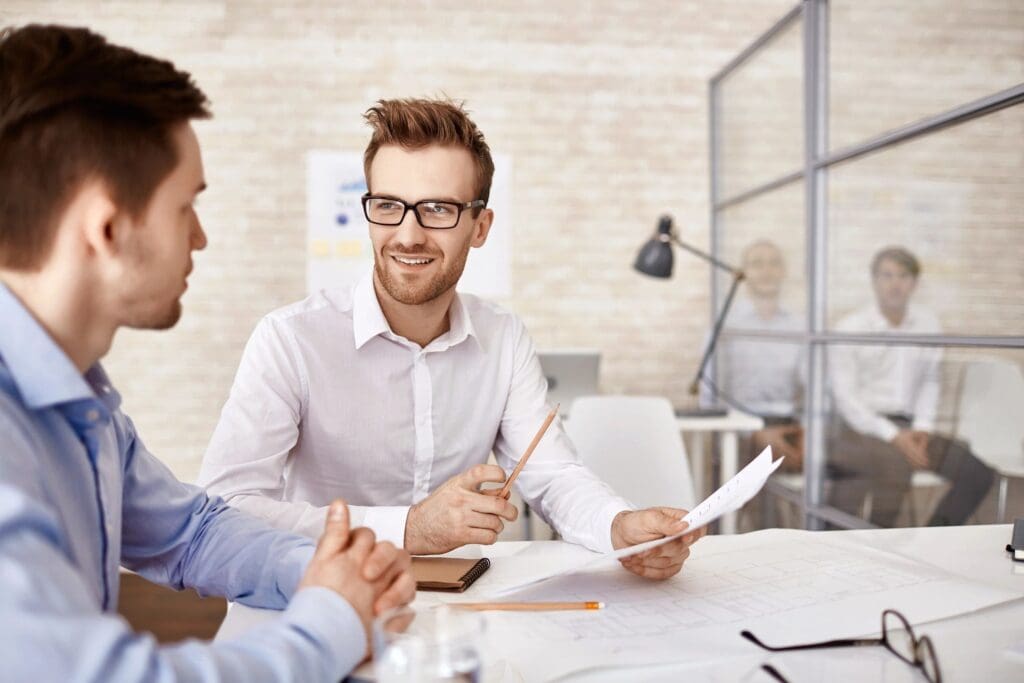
[{"xmin": 374, "ymin": 605, "xmax": 485, "ymax": 683}]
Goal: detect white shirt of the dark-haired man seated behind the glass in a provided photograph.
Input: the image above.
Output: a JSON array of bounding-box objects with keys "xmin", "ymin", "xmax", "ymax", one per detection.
[{"xmin": 828, "ymin": 304, "xmax": 942, "ymax": 441}]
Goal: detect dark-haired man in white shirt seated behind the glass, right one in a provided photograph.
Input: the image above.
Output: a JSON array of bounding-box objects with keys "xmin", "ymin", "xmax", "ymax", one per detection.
[{"xmin": 828, "ymin": 247, "xmax": 994, "ymax": 526}]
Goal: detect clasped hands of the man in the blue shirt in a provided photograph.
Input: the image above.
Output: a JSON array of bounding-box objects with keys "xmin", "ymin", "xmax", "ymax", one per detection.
[{"xmin": 299, "ymin": 500, "xmax": 416, "ymax": 652}]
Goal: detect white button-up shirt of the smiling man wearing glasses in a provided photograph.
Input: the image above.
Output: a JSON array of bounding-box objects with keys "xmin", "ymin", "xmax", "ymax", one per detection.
[{"xmin": 200, "ymin": 274, "xmax": 632, "ymax": 551}]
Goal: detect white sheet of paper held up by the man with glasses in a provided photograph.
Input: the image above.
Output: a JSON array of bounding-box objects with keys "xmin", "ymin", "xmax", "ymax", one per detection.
[{"xmin": 498, "ymin": 445, "xmax": 783, "ymax": 595}]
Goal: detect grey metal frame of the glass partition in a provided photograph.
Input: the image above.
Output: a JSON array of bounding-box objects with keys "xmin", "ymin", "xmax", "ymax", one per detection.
[{"xmin": 709, "ymin": 0, "xmax": 1024, "ymax": 528}]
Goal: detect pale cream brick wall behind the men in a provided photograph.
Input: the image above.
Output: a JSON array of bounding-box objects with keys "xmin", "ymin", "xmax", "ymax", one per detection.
[{"xmin": 0, "ymin": 0, "xmax": 1022, "ymax": 478}]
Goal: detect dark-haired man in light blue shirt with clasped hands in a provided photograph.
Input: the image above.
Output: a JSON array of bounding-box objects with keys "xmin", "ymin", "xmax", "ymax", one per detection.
[{"xmin": 0, "ymin": 26, "xmax": 414, "ymax": 681}]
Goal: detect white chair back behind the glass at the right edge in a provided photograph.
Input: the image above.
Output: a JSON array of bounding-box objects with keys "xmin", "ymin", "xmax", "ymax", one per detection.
[{"xmin": 956, "ymin": 357, "xmax": 1024, "ymax": 476}]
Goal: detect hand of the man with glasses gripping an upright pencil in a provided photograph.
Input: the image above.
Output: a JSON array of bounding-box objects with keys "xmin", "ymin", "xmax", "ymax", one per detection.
[{"xmin": 406, "ymin": 465, "xmax": 519, "ymax": 555}]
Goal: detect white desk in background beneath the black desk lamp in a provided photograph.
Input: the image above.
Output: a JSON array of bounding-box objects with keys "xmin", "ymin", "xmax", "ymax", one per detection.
[{"xmin": 676, "ymin": 409, "xmax": 765, "ymax": 533}]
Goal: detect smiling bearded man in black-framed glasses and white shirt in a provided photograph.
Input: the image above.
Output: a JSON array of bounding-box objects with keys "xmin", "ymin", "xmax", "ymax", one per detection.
[{"xmin": 200, "ymin": 99, "xmax": 700, "ymax": 579}]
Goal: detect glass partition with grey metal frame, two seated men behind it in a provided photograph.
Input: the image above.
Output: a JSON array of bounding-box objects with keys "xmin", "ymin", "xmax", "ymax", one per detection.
[{"xmin": 703, "ymin": 0, "xmax": 1024, "ymax": 528}]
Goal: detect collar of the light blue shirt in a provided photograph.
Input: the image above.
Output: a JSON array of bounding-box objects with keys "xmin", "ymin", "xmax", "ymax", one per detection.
[{"xmin": 0, "ymin": 284, "xmax": 120, "ymax": 410}]
